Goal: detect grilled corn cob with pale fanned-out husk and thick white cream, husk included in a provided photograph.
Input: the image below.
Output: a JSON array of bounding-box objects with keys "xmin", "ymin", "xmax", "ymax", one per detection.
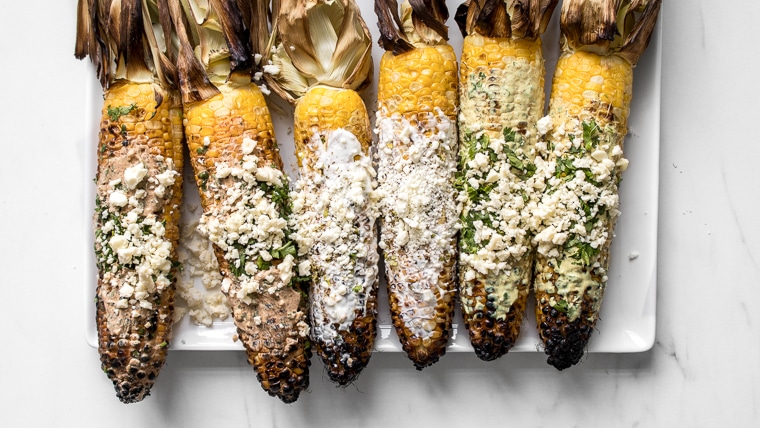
[{"xmin": 267, "ymin": 0, "xmax": 379, "ymax": 385}]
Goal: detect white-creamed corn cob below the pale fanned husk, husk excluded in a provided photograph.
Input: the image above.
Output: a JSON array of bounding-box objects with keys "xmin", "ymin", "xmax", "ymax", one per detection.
[{"xmin": 291, "ymin": 86, "xmax": 378, "ymax": 385}]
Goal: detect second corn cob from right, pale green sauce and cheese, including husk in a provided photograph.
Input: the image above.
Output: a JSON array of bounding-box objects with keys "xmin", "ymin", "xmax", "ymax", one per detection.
[{"xmin": 457, "ymin": 0, "xmax": 556, "ymax": 361}]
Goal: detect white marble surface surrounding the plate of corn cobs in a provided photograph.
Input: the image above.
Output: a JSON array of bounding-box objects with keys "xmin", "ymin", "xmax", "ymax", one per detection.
[{"xmin": 0, "ymin": 0, "xmax": 760, "ymax": 427}]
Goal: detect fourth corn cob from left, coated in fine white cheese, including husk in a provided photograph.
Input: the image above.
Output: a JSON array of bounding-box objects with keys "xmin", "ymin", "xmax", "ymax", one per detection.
[{"xmin": 375, "ymin": 0, "xmax": 459, "ymax": 369}]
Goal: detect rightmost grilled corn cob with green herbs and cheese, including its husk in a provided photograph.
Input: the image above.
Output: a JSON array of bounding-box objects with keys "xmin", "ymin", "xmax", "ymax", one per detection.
[{"xmin": 535, "ymin": 0, "xmax": 660, "ymax": 370}]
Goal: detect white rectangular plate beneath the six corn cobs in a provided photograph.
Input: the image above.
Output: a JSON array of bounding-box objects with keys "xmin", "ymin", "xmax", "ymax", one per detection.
[{"xmin": 82, "ymin": 5, "xmax": 661, "ymax": 353}]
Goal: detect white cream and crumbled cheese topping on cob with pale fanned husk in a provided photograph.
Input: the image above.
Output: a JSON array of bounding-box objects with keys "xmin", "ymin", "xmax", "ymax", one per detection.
[{"xmin": 290, "ymin": 129, "xmax": 378, "ymax": 346}]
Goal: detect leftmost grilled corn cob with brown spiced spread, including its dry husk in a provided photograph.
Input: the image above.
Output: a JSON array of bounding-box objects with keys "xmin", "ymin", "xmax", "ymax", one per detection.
[{"xmin": 75, "ymin": 1, "xmax": 183, "ymax": 403}]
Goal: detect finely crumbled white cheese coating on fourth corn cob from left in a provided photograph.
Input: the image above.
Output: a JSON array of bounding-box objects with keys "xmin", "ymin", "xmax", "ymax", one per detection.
[{"xmin": 375, "ymin": 108, "xmax": 459, "ymax": 339}]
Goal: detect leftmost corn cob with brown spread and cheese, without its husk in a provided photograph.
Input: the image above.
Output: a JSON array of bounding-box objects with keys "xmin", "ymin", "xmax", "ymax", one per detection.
[{"xmin": 94, "ymin": 82, "xmax": 183, "ymax": 403}]
